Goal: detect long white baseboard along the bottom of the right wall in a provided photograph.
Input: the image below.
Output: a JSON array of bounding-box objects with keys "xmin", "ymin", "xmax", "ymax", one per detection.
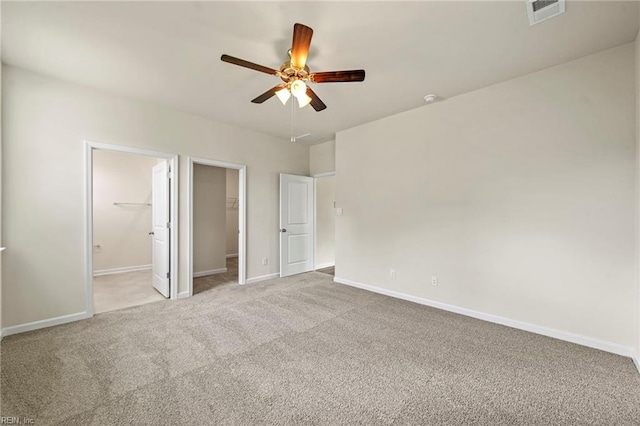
[{"xmin": 333, "ymin": 277, "xmax": 633, "ymax": 357}]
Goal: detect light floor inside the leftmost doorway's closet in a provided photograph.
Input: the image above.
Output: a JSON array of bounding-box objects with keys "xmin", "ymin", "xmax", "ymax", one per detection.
[{"xmin": 93, "ymin": 269, "xmax": 166, "ymax": 314}]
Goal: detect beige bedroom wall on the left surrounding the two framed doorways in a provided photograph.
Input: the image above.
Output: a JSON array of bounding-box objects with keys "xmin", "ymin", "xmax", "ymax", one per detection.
[{"xmin": 2, "ymin": 66, "xmax": 309, "ymax": 327}]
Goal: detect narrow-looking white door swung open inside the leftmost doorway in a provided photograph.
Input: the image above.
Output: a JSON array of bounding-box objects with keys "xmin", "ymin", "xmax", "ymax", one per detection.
[{"xmin": 151, "ymin": 161, "xmax": 171, "ymax": 297}]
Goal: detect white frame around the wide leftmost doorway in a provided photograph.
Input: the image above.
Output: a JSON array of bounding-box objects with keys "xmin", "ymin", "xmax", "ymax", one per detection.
[{"xmin": 84, "ymin": 140, "xmax": 179, "ymax": 318}]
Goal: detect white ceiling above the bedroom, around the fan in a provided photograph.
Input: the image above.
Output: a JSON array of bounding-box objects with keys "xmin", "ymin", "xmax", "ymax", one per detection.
[{"xmin": 2, "ymin": 0, "xmax": 638, "ymax": 143}]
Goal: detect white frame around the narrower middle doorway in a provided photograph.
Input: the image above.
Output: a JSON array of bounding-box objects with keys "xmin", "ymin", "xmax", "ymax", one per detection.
[{"xmin": 188, "ymin": 157, "xmax": 247, "ymax": 299}]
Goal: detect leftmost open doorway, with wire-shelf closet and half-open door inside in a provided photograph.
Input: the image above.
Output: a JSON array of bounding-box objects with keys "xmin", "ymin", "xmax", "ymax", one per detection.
[{"xmin": 86, "ymin": 142, "xmax": 177, "ymax": 314}]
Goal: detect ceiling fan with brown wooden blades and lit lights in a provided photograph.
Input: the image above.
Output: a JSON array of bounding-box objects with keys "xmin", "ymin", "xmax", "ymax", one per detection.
[{"xmin": 220, "ymin": 24, "xmax": 364, "ymax": 111}]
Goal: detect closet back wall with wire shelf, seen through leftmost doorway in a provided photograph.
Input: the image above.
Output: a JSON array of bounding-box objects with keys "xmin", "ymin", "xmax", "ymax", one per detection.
[{"xmin": 93, "ymin": 150, "xmax": 158, "ymax": 273}]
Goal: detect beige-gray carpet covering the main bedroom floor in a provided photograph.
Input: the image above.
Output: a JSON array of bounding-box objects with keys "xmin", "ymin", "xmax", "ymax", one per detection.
[{"xmin": 1, "ymin": 272, "xmax": 640, "ymax": 425}]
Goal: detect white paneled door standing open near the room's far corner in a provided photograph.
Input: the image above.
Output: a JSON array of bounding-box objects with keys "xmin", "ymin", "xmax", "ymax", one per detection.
[{"xmin": 280, "ymin": 174, "xmax": 315, "ymax": 277}]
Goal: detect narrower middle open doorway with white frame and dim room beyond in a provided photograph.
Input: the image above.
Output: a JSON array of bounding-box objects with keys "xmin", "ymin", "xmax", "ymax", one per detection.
[{"xmin": 188, "ymin": 159, "xmax": 246, "ymax": 297}]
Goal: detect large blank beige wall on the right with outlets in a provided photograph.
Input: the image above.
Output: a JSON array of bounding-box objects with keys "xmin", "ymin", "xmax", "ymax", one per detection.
[{"xmin": 336, "ymin": 44, "xmax": 638, "ymax": 349}]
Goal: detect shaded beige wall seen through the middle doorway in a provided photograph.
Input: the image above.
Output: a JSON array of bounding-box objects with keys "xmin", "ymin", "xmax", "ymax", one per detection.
[{"xmin": 193, "ymin": 164, "xmax": 227, "ymax": 276}]
